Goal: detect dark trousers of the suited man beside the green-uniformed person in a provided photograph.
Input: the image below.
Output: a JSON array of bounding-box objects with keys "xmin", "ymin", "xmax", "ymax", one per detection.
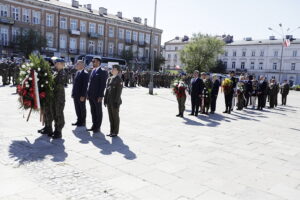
[{"xmin": 89, "ymin": 98, "xmax": 103, "ymax": 130}]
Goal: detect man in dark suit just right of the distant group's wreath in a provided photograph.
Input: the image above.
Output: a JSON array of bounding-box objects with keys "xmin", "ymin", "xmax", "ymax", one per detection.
[{"xmin": 190, "ymin": 70, "xmax": 204, "ymax": 116}]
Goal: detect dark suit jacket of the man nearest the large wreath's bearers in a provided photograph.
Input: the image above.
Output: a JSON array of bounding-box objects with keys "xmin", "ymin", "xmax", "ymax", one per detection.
[{"xmin": 72, "ymin": 70, "xmax": 89, "ymax": 97}]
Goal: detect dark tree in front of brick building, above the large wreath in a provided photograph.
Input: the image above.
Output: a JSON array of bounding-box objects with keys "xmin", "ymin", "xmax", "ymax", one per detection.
[{"xmin": 15, "ymin": 29, "xmax": 47, "ymax": 58}]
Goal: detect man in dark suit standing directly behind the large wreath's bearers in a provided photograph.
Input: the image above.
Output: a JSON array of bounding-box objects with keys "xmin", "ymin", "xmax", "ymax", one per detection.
[{"xmin": 72, "ymin": 60, "xmax": 89, "ymax": 126}]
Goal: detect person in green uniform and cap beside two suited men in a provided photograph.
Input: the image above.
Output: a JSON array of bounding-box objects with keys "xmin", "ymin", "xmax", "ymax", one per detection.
[{"xmin": 104, "ymin": 65, "xmax": 123, "ymax": 137}]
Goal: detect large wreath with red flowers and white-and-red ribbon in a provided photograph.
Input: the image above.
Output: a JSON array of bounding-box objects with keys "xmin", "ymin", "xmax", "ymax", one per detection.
[{"xmin": 17, "ymin": 55, "xmax": 53, "ymax": 121}]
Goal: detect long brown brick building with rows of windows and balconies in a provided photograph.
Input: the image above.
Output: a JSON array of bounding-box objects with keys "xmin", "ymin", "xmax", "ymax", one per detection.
[{"xmin": 0, "ymin": 0, "xmax": 162, "ymax": 63}]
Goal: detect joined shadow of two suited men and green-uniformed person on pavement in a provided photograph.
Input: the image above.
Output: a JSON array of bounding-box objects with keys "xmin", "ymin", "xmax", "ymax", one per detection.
[{"xmin": 73, "ymin": 127, "xmax": 136, "ymax": 160}]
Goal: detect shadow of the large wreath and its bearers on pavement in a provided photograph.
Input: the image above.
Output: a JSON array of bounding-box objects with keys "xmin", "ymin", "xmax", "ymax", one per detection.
[{"xmin": 9, "ymin": 136, "xmax": 68, "ymax": 165}]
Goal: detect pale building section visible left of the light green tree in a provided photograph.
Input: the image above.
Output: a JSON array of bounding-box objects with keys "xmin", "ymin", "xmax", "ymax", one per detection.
[{"xmin": 163, "ymin": 36, "xmax": 189, "ymax": 69}]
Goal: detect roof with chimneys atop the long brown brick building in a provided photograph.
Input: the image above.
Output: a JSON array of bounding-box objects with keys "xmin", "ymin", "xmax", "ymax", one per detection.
[{"xmin": 36, "ymin": 0, "xmax": 162, "ymax": 31}]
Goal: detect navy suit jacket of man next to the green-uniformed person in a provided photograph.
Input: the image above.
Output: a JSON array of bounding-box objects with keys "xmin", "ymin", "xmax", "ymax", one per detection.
[{"xmin": 88, "ymin": 68, "xmax": 108, "ymax": 99}]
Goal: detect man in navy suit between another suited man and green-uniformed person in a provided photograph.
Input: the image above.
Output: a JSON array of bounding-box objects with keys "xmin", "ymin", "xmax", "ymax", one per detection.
[{"xmin": 87, "ymin": 57, "xmax": 108, "ymax": 133}]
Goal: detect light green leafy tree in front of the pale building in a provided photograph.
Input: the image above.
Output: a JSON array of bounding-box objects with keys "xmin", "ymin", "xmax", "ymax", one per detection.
[{"xmin": 180, "ymin": 33, "xmax": 225, "ymax": 73}]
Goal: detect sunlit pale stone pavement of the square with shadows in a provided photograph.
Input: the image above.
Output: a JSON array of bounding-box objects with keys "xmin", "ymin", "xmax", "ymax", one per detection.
[{"xmin": 0, "ymin": 83, "xmax": 300, "ymax": 200}]
